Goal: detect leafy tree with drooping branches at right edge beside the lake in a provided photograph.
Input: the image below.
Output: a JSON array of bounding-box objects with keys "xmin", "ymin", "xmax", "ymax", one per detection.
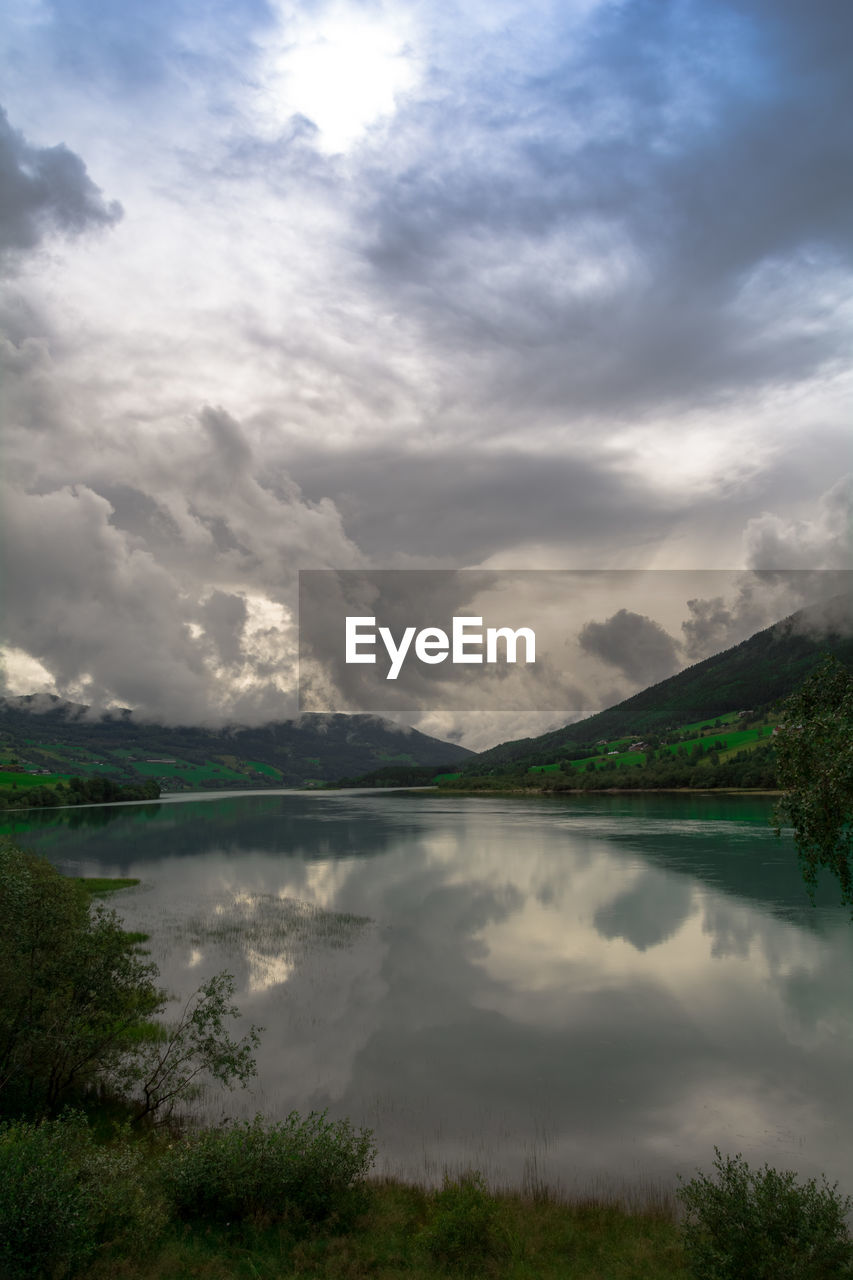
[{"xmin": 776, "ymin": 657, "xmax": 853, "ymax": 906}]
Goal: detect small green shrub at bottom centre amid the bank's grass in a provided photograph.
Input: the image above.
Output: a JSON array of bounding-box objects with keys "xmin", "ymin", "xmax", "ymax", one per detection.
[{"xmin": 419, "ymin": 1172, "xmax": 510, "ymax": 1272}]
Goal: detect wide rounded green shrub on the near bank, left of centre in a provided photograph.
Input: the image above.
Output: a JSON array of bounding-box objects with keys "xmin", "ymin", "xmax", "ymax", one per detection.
[{"xmin": 160, "ymin": 1111, "xmax": 375, "ymax": 1222}]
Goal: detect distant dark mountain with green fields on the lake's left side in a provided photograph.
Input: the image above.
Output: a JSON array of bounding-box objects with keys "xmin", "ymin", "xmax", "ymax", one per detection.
[{"xmin": 0, "ymin": 695, "xmax": 471, "ymax": 790}]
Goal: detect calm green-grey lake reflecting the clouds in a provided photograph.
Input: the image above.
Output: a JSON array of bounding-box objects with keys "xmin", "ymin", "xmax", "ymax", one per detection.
[{"xmin": 3, "ymin": 791, "xmax": 853, "ymax": 1198}]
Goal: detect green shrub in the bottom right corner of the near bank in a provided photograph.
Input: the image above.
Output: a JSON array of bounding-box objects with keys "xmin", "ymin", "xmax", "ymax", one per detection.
[{"xmin": 678, "ymin": 1147, "xmax": 853, "ymax": 1280}]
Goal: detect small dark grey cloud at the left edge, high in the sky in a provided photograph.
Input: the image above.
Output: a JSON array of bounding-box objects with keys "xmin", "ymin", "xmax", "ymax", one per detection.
[{"xmin": 0, "ymin": 109, "xmax": 122, "ymax": 264}]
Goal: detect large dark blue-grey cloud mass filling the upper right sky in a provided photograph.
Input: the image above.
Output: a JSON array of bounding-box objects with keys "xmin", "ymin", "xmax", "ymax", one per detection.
[{"xmin": 362, "ymin": 0, "xmax": 853, "ymax": 413}]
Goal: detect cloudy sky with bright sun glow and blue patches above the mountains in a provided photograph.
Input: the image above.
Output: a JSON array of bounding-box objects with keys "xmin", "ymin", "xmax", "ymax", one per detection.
[{"xmin": 0, "ymin": 0, "xmax": 853, "ymax": 746}]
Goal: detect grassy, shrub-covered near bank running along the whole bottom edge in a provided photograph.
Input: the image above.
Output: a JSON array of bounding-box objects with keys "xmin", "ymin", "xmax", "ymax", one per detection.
[{"xmin": 0, "ymin": 1110, "xmax": 853, "ymax": 1280}]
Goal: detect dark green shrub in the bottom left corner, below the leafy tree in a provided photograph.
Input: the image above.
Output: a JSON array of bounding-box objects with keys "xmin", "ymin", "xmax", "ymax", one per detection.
[{"xmin": 0, "ymin": 1112, "xmax": 165, "ymax": 1280}]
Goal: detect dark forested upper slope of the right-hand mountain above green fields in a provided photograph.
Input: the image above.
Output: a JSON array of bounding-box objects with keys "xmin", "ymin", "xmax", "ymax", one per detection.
[{"xmin": 462, "ymin": 595, "xmax": 853, "ymax": 774}]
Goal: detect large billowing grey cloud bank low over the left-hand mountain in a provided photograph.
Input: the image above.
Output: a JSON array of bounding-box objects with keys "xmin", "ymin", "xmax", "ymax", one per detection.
[{"xmin": 3, "ymin": 408, "xmax": 355, "ymax": 723}]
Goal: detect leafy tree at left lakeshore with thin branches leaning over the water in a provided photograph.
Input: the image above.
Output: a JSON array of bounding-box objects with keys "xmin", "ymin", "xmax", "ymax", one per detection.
[{"xmin": 0, "ymin": 840, "xmax": 257, "ymax": 1117}]
